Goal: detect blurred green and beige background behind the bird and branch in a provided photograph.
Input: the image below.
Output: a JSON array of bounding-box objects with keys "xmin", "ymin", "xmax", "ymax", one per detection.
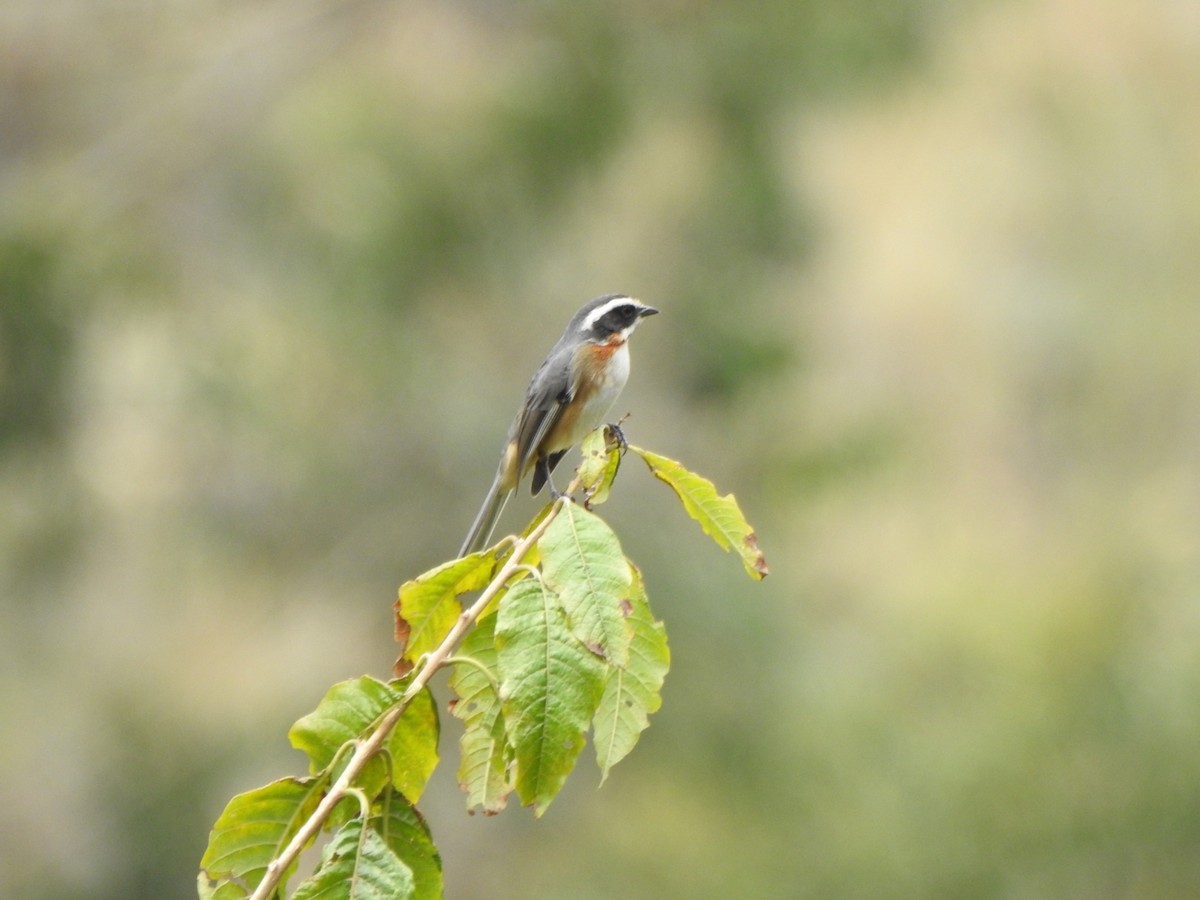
[{"xmin": 0, "ymin": 0, "xmax": 1200, "ymax": 900}]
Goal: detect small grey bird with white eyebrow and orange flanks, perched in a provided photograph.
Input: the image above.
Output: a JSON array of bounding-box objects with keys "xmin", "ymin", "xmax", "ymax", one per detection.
[{"xmin": 458, "ymin": 294, "xmax": 658, "ymax": 558}]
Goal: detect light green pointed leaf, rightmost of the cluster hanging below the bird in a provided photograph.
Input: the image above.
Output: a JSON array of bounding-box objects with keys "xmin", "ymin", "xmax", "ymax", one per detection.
[{"xmin": 592, "ymin": 569, "xmax": 671, "ymax": 782}]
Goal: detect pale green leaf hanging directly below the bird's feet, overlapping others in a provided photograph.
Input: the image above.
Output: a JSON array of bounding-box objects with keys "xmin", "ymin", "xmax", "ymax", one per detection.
[{"xmin": 538, "ymin": 503, "xmax": 631, "ymax": 666}]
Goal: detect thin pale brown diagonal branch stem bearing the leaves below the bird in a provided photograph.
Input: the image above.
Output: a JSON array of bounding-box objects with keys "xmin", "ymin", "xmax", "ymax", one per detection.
[{"xmin": 250, "ymin": 496, "xmax": 568, "ymax": 900}]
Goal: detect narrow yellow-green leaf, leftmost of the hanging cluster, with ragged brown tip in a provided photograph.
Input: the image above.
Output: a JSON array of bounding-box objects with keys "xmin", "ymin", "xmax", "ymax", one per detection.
[{"xmin": 450, "ymin": 616, "xmax": 512, "ymax": 815}]
